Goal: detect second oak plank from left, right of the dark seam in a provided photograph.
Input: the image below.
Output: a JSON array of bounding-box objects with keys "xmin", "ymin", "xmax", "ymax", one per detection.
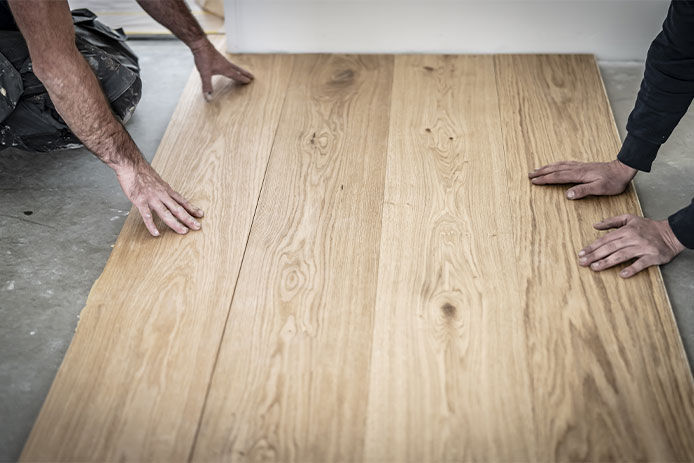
[{"xmin": 193, "ymin": 55, "xmax": 393, "ymax": 462}]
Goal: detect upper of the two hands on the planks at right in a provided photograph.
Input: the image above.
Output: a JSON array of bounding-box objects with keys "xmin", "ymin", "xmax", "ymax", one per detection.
[{"xmin": 528, "ymin": 159, "xmax": 637, "ymax": 199}]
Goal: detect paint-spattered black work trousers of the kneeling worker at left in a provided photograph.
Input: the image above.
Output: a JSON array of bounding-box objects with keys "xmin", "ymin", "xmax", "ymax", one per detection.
[{"xmin": 0, "ymin": 8, "xmax": 142, "ymax": 151}]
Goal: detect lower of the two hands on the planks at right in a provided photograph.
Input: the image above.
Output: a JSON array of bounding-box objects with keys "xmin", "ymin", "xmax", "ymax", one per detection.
[{"xmin": 578, "ymin": 214, "xmax": 684, "ymax": 278}]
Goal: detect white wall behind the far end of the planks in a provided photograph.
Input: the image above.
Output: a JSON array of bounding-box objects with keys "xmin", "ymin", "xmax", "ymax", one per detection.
[{"xmin": 224, "ymin": 0, "xmax": 669, "ymax": 60}]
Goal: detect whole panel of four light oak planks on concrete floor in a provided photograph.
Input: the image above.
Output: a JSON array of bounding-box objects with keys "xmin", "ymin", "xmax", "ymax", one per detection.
[{"xmin": 22, "ymin": 55, "xmax": 694, "ymax": 462}]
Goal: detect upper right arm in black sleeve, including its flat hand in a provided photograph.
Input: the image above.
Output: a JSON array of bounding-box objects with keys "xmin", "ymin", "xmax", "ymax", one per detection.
[{"xmin": 529, "ymin": 1, "xmax": 694, "ymax": 191}]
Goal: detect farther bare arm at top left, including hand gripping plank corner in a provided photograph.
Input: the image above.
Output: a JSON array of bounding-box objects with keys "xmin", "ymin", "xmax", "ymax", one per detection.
[{"xmin": 137, "ymin": 0, "xmax": 253, "ymax": 100}]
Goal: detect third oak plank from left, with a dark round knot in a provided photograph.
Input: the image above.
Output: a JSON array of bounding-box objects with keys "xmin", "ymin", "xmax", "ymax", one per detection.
[{"xmin": 365, "ymin": 55, "xmax": 533, "ymax": 461}]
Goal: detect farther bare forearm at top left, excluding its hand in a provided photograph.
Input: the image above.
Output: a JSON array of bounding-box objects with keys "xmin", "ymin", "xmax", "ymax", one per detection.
[{"xmin": 137, "ymin": 0, "xmax": 207, "ymax": 49}]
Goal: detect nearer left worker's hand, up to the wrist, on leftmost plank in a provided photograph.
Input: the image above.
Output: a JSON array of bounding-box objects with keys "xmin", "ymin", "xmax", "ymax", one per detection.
[{"xmin": 116, "ymin": 160, "xmax": 203, "ymax": 236}]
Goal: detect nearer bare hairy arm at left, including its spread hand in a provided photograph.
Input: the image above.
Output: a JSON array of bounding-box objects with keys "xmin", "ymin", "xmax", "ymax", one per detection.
[{"xmin": 9, "ymin": 0, "xmax": 202, "ymax": 236}]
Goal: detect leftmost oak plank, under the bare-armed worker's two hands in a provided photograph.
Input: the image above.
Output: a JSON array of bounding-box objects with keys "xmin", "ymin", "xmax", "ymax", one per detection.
[{"xmin": 22, "ymin": 52, "xmax": 292, "ymax": 461}]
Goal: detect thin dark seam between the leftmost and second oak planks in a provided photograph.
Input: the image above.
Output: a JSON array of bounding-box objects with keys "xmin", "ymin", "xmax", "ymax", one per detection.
[{"xmin": 186, "ymin": 55, "xmax": 294, "ymax": 462}]
